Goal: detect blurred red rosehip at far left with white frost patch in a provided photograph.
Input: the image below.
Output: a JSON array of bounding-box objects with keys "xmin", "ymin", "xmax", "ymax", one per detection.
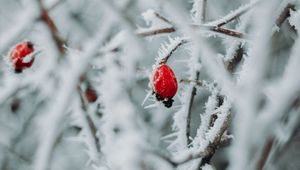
[{"xmin": 9, "ymin": 41, "xmax": 34, "ymax": 73}]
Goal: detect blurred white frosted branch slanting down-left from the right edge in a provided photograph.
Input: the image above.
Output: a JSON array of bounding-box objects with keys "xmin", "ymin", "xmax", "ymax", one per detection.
[{"xmin": 255, "ymin": 35, "xmax": 300, "ymax": 143}]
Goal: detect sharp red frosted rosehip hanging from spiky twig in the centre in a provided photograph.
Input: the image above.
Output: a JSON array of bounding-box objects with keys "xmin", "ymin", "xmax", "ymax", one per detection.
[{"xmin": 152, "ymin": 63, "xmax": 178, "ymax": 108}]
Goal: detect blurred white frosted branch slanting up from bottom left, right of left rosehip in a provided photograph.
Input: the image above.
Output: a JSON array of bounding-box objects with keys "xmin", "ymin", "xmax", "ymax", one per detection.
[{"xmin": 34, "ymin": 21, "xmax": 110, "ymax": 170}]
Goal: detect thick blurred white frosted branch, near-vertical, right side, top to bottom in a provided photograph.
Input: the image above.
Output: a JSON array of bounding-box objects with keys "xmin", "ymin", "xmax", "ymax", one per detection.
[{"xmin": 229, "ymin": 0, "xmax": 288, "ymax": 170}]
